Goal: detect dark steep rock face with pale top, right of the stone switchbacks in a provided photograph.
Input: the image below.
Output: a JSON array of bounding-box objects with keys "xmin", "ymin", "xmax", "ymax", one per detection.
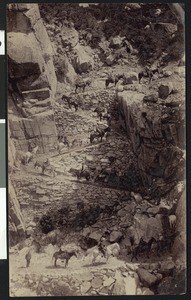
[{"xmin": 117, "ymin": 91, "xmax": 184, "ymax": 194}]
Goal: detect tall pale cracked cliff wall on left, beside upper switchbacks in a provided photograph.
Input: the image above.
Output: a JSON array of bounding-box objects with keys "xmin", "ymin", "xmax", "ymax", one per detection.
[{"xmin": 7, "ymin": 4, "xmax": 57, "ymax": 152}]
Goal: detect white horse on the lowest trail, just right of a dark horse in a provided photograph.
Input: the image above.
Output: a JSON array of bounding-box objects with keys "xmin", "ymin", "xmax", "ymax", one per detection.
[{"xmin": 85, "ymin": 243, "xmax": 120, "ymax": 264}]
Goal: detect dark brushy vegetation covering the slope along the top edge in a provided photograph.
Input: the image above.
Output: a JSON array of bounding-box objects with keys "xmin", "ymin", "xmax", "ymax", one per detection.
[{"xmin": 39, "ymin": 3, "xmax": 183, "ymax": 64}]
